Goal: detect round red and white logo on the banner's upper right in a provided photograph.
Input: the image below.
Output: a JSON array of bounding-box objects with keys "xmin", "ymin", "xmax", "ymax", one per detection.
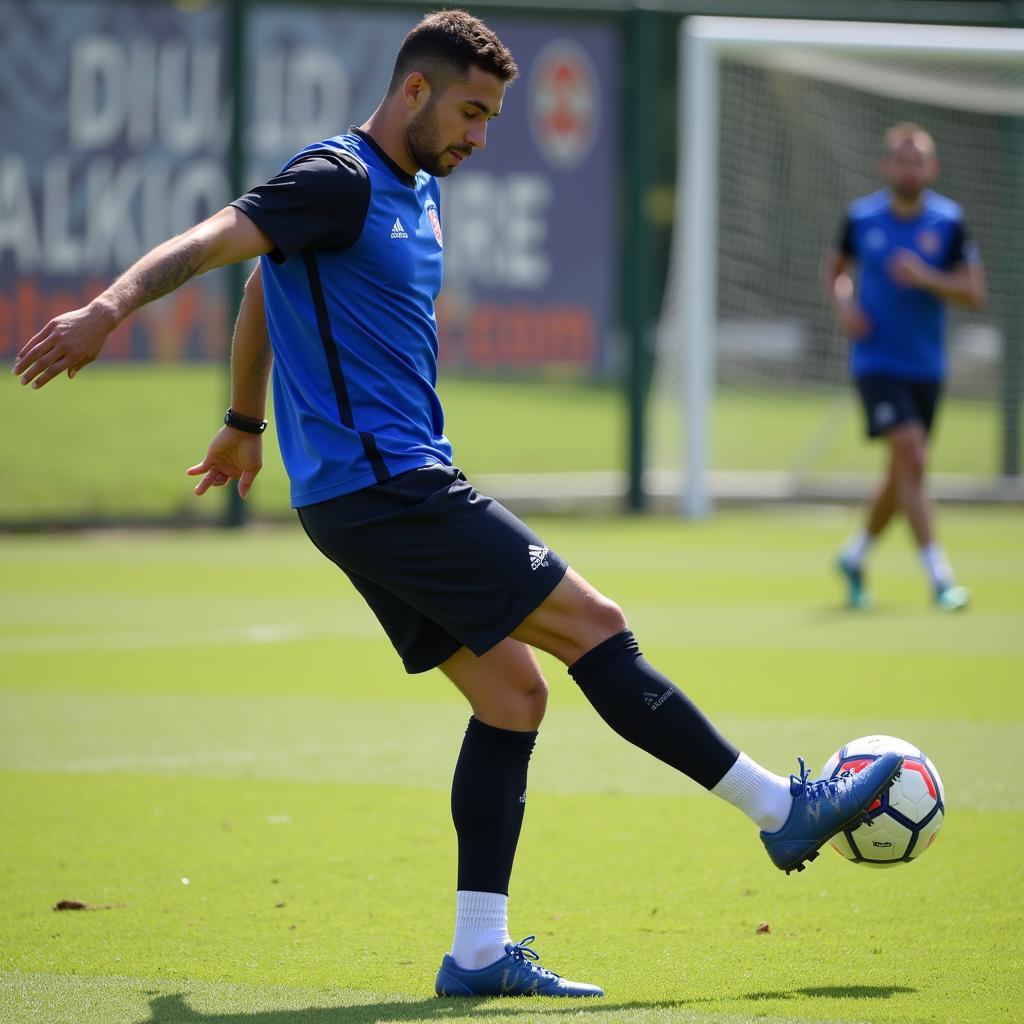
[{"xmin": 529, "ymin": 39, "xmax": 599, "ymax": 170}]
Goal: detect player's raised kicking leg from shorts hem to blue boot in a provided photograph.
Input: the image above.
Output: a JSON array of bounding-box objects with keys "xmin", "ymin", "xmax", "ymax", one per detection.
[{"xmin": 513, "ymin": 569, "xmax": 899, "ymax": 873}]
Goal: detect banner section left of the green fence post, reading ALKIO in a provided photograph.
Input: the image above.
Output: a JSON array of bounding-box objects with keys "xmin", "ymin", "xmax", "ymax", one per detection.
[{"xmin": 0, "ymin": 0, "xmax": 228, "ymax": 361}]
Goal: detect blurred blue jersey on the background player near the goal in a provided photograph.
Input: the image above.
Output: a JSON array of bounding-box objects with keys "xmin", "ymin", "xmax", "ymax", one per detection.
[{"xmin": 840, "ymin": 190, "xmax": 977, "ymax": 381}]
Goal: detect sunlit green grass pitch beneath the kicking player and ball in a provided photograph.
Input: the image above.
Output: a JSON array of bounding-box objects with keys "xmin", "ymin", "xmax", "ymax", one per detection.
[{"xmin": 0, "ymin": 508, "xmax": 1024, "ymax": 1024}]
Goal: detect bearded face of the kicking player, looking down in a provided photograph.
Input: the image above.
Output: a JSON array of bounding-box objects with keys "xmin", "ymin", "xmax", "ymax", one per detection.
[{"xmin": 406, "ymin": 68, "xmax": 505, "ymax": 178}]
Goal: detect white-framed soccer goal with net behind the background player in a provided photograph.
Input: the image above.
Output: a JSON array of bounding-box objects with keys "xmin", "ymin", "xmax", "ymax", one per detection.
[{"xmin": 647, "ymin": 17, "xmax": 1024, "ymax": 515}]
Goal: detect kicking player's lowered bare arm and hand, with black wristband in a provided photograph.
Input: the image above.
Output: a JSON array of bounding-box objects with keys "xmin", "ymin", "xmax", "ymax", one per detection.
[{"xmin": 187, "ymin": 266, "xmax": 273, "ymax": 499}]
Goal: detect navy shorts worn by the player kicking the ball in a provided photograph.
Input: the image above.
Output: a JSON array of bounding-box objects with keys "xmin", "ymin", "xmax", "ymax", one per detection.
[{"xmin": 297, "ymin": 465, "xmax": 566, "ymax": 673}]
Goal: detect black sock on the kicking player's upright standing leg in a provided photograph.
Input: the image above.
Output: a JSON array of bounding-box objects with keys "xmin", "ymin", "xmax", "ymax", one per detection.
[{"xmin": 452, "ymin": 718, "xmax": 537, "ymax": 896}]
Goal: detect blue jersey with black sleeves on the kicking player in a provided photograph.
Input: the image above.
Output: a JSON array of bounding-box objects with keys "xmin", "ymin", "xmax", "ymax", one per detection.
[{"xmin": 232, "ymin": 129, "xmax": 452, "ymax": 507}]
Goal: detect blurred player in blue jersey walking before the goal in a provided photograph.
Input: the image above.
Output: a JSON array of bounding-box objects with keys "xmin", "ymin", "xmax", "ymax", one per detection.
[{"xmin": 824, "ymin": 123, "xmax": 985, "ymax": 610}]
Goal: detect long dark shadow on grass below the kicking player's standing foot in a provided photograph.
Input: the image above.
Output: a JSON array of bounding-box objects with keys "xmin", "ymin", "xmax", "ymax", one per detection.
[{"xmin": 139, "ymin": 993, "xmax": 719, "ymax": 1024}]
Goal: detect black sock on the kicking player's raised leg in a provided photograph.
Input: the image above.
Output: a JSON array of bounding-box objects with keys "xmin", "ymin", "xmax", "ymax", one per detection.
[{"xmin": 569, "ymin": 630, "xmax": 739, "ymax": 790}]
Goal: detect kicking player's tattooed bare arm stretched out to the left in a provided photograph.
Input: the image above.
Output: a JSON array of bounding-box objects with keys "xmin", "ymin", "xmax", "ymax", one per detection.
[{"xmin": 13, "ymin": 206, "xmax": 273, "ymax": 388}]
